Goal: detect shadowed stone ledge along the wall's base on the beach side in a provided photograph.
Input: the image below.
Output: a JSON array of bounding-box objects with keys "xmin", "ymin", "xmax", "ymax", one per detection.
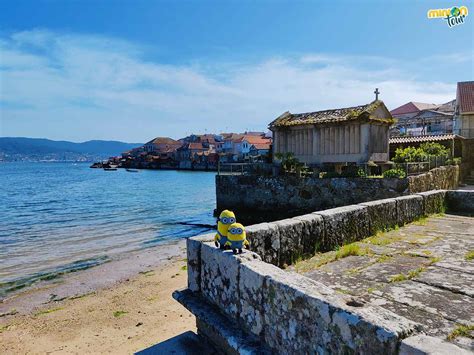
[{"xmin": 173, "ymin": 290, "xmax": 270, "ymax": 355}]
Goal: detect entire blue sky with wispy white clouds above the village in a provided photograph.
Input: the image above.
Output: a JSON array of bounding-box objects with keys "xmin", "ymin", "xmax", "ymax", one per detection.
[{"xmin": 0, "ymin": 0, "xmax": 474, "ymax": 142}]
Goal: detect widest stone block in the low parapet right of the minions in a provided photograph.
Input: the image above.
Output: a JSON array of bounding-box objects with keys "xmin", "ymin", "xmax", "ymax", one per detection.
[{"xmin": 315, "ymin": 205, "xmax": 370, "ymax": 251}]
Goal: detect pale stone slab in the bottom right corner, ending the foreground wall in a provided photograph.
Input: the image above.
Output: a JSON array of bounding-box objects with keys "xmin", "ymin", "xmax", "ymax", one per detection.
[{"xmin": 399, "ymin": 335, "xmax": 472, "ymax": 355}]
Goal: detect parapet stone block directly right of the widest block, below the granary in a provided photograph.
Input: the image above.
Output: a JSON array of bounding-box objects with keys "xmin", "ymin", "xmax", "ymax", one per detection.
[{"xmin": 360, "ymin": 199, "xmax": 398, "ymax": 235}]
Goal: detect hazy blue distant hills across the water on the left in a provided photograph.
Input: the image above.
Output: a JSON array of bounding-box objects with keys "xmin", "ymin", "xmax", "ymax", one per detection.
[{"xmin": 0, "ymin": 137, "xmax": 142, "ymax": 161}]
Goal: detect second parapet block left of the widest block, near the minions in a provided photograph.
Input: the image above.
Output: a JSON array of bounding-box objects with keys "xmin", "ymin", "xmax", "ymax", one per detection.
[{"xmin": 275, "ymin": 218, "xmax": 304, "ymax": 266}]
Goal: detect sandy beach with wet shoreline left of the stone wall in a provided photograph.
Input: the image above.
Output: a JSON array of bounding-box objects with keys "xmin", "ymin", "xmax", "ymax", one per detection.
[{"xmin": 0, "ymin": 241, "xmax": 195, "ymax": 354}]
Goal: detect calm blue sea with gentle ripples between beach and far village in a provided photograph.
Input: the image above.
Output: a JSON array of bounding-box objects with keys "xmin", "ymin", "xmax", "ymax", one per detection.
[{"xmin": 0, "ymin": 163, "xmax": 215, "ymax": 296}]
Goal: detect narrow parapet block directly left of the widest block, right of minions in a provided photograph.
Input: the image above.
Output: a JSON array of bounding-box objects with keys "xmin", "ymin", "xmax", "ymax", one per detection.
[{"xmin": 294, "ymin": 213, "xmax": 325, "ymax": 256}]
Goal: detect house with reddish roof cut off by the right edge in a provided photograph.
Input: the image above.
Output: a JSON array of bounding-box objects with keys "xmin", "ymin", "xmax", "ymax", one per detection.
[{"xmin": 455, "ymin": 81, "xmax": 474, "ymax": 138}]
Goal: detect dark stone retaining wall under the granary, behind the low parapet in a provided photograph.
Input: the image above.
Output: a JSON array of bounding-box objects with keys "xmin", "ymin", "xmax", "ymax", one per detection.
[{"xmin": 216, "ymin": 166, "xmax": 459, "ymax": 224}]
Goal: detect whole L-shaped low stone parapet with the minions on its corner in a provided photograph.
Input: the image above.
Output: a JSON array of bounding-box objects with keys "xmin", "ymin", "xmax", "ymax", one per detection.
[{"xmin": 174, "ymin": 190, "xmax": 474, "ymax": 354}]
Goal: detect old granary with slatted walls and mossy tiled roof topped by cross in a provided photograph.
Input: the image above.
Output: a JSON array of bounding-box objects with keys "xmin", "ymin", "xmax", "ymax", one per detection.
[{"xmin": 269, "ymin": 99, "xmax": 394, "ymax": 168}]
